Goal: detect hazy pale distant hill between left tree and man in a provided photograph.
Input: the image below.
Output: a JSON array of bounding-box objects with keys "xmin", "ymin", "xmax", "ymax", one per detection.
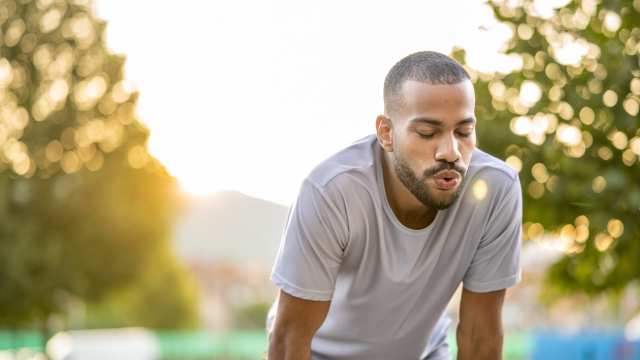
[{"xmin": 174, "ymin": 191, "xmax": 288, "ymax": 268}]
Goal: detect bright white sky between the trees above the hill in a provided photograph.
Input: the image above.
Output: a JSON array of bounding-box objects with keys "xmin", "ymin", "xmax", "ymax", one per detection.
[{"xmin": 95, "ymin": 0, "xmax": 512, "ymax": 205}]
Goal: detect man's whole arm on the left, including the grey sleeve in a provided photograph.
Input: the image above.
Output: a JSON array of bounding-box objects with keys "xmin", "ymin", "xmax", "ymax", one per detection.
[{"xmin": 268, "ymin": 180, "xmax": 349, "ymax": 360}]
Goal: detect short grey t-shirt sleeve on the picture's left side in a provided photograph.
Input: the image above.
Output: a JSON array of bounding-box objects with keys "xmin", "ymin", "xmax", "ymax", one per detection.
[{"xmin": 271, "ymin": 180, "xmax": 347, "ymax": 300}]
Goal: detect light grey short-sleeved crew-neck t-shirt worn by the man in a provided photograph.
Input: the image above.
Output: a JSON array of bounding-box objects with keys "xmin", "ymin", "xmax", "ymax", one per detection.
[{"xmin": 271, "ymin": 135, "xmax": 522, "ymax": 360}]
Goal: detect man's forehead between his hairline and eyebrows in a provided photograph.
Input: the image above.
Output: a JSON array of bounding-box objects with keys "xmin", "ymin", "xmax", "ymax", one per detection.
[{"xmin": 400, "ymin": 80, "xmax": 475, "ymax": 115}]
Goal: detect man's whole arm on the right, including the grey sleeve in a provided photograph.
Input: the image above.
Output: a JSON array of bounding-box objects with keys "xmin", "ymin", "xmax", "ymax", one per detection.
[{"xmin": 457, "ymin": 177, "xmax": 522, "ymax": 360}]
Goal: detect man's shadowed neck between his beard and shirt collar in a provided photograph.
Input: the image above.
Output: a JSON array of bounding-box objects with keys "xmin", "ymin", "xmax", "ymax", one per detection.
[{"xmin": 381, "ymin": 151, "xmax": 438, "ymax": 229}]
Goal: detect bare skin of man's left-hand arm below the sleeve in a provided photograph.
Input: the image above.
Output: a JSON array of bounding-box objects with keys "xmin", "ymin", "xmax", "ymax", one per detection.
[{"xmin": 267, "ymin": 290, "xmax": 331, "ymax": 360}]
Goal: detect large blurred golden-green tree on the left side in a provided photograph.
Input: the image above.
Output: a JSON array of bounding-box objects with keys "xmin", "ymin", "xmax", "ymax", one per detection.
[{"xmin": 0, "ymin": 0, "xmax": 198, "ymax": 329}]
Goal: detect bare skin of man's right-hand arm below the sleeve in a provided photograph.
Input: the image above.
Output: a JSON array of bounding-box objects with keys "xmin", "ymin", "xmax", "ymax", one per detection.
[{"xmin": 456, "ymin": 289, "xmax": 506, "ymax": 360}]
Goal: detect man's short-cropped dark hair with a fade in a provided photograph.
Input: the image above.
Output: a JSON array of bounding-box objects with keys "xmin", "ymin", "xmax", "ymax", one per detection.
[{"xmin": 384, "ymin": 51, "xmax": 470, "ymax": 114}]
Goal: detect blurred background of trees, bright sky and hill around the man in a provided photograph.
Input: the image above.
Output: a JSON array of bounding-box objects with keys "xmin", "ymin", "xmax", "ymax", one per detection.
[{"xmin": 0, "ymin": 0, "xmax": 640, "ymax": 360}]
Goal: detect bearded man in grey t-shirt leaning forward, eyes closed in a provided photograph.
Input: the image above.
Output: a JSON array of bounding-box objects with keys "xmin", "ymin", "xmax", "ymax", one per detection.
[{"xmin": 268, "ymin": 52, "xmax": 522, "ymax": 360}]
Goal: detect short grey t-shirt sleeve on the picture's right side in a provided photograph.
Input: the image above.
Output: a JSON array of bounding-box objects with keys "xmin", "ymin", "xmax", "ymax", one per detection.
[{"xmin": 463, "ymin": 177, "xmax": 522, "ymax": 293}]
